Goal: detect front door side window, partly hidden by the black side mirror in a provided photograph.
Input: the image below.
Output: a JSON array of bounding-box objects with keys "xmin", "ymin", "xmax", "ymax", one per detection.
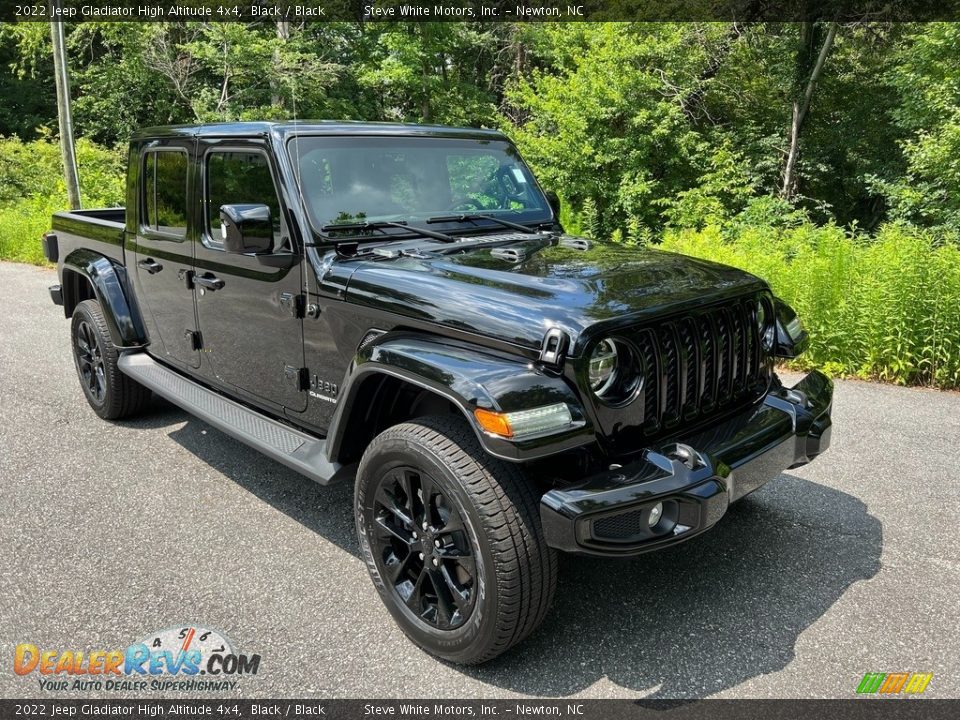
[{"xmin": 206, "ymin": 150, "xmax": 281, "ymax": 247}]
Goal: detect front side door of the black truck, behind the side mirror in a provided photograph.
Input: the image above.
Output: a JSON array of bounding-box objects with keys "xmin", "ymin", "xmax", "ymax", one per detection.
[{"xmin": 194, "ymin": 139, "xmax": 307, "ymax": 412}]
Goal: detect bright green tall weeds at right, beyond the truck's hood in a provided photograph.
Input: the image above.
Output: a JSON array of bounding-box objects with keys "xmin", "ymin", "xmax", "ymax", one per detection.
[{"xmin": 662, "ymin": 223, "xmax": 960, "ymax": 388}]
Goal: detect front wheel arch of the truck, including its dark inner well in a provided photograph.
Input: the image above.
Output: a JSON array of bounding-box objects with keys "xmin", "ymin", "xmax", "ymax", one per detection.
[{"xmin": 327, "ymin": 334, "xmax": 593, "ymax": 463}]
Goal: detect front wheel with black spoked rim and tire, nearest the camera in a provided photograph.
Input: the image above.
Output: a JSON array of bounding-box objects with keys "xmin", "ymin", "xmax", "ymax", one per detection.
[{"xmin": 354, "ymin": 416, "xmax": 557, "ymax": 664}]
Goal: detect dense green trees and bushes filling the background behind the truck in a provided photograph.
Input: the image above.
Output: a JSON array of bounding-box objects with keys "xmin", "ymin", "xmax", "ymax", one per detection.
[{"xmin": 0, "ymin": 22, "xmax": 960, "ymax": 386}]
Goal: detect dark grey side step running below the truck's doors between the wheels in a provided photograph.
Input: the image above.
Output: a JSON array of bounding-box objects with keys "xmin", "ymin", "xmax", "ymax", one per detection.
[{"xmin": 117, "ymin": 352, "xmax": 354, "ymax": 485}]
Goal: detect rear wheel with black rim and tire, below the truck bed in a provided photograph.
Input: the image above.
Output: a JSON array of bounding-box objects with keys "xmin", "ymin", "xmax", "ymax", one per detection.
[{"xmin": 70, "ymin": 300, "xmax": 150, "ymax": 420}]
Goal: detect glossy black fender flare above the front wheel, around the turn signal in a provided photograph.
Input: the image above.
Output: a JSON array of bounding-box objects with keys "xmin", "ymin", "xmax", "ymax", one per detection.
[{"xmin": 327, "ymin": 333, "xmax": 594, "ymax": 462}]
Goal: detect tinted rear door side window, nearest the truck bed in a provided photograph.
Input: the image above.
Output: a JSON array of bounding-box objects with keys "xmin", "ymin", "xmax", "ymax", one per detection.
[{"xmin": 140, "ymin": 151, "xmax": 187, "ymax": 238}]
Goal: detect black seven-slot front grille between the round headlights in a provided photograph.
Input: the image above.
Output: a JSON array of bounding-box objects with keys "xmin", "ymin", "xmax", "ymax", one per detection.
[{"xmin": 627, "ymin": 296, "xmax": 769, "ymax": 436}]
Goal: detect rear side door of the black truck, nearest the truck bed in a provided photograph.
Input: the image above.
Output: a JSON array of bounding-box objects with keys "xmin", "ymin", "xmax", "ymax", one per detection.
[{"xmin": 131, "ymin": 138, "xmax": 200, "ymax": 368}]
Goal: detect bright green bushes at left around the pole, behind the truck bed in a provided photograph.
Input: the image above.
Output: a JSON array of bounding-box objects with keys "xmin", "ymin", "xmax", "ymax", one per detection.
[{"xmin": 0, "ymin": 138, "xmax": 124, "ymax": 265}]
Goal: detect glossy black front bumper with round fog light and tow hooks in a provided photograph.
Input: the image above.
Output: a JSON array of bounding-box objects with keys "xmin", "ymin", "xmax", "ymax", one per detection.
[{"xmin": 540, "ymin": 371, "xmax": 833, "ymax": 555}]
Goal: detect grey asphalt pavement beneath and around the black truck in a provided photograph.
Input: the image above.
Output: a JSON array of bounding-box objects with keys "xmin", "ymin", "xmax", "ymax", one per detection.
[{"xmin": 0, "ymin": 263, "xmax": 960, "ymax": 698}]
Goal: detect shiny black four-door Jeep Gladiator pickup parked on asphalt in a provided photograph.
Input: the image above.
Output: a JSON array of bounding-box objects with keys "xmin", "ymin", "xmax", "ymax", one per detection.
[{"xmin": 43, "ymin": 122, "xmax": 833, "ymax": 663}]
